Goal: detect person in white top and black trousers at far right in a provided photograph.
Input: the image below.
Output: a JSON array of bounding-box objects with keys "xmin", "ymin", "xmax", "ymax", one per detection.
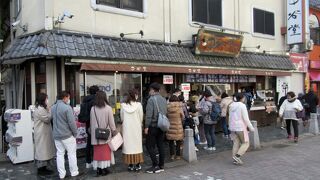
[{"xmin": 279, "ymin": 92, "xmax": 303, "ymax": 143}]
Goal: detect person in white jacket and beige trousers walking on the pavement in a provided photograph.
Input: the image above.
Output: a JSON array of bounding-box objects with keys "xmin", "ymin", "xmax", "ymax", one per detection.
[{"xmin": 229, "ymin": 93, "xmax": 254, "ymax": 165}]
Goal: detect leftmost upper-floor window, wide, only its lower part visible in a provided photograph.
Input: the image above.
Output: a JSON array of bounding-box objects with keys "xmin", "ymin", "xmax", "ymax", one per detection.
[{"xmin": 96, "ymin": 0, "xmax": 143, "ymax": 12}]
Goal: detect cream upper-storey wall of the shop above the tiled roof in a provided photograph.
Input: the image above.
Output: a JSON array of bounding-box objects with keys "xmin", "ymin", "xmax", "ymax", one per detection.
[{"xmin": 14, "ymin": 0, "xmax": 285, "ymax": 54}]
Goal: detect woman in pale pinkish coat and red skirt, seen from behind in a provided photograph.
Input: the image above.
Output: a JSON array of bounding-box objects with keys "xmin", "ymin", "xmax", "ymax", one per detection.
[{"xmin": 90, "ymin": 91, "xmax": 116, "ymax": 176}]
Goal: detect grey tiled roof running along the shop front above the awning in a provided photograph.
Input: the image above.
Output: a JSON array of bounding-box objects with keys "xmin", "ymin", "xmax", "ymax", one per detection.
[{"xmin": 1, "ymin": 31, "xmax": 294, "ymax": 70}]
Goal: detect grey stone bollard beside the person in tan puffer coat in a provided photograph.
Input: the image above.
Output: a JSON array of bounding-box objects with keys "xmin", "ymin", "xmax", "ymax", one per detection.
[{"xmin": 183, "ymin": 128, "xmax": 197, "ymax": 163}]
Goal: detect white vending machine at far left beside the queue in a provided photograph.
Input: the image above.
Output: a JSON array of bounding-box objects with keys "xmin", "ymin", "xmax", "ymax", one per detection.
[{"xmin": 4, "ymin": 109, "xmax": 34, "ymax": 164}]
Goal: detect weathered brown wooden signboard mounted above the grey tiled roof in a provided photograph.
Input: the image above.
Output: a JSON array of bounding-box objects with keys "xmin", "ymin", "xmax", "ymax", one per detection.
[{"xmin": 195, "ymin": 29, "xmax": 243, "ymax": 57}]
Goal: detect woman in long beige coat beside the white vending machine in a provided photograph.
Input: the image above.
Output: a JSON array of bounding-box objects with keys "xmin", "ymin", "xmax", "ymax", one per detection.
[{"xmin": 33, "ymin": 93, "xmax": 56, "ymax": 175}]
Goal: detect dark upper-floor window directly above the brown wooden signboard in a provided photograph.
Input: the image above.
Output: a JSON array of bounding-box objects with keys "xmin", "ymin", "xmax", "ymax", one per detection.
[{"xmin": 192, "ymin": 0, "xmax": 222, "ymax": 26}]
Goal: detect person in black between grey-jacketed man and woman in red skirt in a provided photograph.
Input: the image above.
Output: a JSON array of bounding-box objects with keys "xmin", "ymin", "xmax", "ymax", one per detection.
[{"xmin": 78, "ymin": 86, "xmax": 99, "ymax": 168}]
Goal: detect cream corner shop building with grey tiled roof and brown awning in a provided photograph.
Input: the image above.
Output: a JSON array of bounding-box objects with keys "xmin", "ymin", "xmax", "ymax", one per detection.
[{"xmin": 1, "ymin": 0, "xmax": 295, "ymax": 128}]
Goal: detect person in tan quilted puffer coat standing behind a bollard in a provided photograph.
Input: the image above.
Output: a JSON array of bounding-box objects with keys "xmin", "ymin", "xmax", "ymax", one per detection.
[{"xmin": 167, "ymin": 96, "xmax": 184, "ymax": 160}]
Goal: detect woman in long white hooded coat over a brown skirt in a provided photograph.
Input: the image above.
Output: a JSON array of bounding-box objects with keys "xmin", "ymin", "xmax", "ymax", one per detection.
[{"xmin": 120, "ymin": 90, "xmax": 143, "ymax": 171}]
